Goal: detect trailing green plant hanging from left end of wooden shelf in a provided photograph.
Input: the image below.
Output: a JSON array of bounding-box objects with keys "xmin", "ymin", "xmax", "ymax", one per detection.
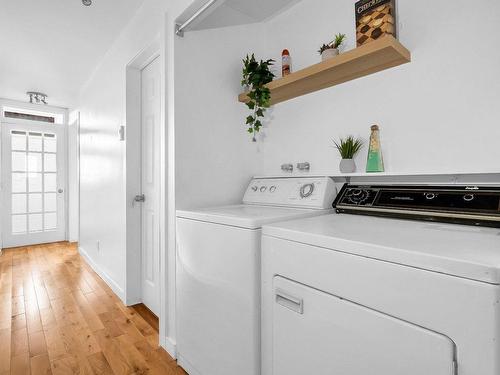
[{"xmin": 241, "ymin": 54, "xmax": 275, "ymax": 142}]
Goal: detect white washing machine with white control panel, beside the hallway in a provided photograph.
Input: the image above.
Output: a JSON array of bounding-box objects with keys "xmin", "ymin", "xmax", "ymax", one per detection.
[{"xmin": 176, "ymin": 178, "xmax": 336, "ymax": 375}]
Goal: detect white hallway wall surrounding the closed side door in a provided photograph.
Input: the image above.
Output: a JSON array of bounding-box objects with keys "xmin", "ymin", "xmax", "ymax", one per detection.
[{"xmin": 79, "ymin": 0, "xmax": 189, "ymax": 354}]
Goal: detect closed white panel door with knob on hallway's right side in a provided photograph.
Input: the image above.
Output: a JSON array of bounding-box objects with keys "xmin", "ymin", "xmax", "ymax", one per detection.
[{"xmin": 141, "ymin": 58, "xmax": 161, "ymax": 316}]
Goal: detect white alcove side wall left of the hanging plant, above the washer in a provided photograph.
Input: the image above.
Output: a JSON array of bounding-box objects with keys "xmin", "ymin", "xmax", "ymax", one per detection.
[{"xmin": 175, "ymin": 25, "xmax": 265, "ymax": 209}]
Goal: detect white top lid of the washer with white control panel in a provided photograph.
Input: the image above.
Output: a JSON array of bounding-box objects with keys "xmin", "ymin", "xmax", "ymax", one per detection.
[{"xmin": 177, "ymin": 204, "xmax": 333, "ymax": 229}]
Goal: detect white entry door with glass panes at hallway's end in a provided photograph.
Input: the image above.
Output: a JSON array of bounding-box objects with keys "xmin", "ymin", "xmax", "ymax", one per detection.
[{"xmin": 1, "ymin": 123, "xmax": 66, "ymax": 248}]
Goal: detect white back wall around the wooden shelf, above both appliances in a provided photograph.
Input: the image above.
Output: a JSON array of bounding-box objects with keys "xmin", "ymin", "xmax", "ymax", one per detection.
[{"xmin": 261, "ymin": 0, "xmax": 500, "ymax": 174}]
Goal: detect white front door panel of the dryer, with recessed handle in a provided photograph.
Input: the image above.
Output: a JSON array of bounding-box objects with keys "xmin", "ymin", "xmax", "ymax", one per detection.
[{"xmin": 272, "ymin": 277, "xmax": 456, "ymax": 375}]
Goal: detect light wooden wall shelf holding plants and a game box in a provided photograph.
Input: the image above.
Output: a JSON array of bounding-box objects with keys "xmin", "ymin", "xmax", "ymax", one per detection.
[{"xmin": 238, "ymin": 35, "xmax": 411, "ymax": 104}]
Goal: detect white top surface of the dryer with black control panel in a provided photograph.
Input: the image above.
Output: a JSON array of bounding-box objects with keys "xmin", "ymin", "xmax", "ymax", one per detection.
[{"xmin": 263, "ymin": 214, "xmax": 500, "ymax": 285}]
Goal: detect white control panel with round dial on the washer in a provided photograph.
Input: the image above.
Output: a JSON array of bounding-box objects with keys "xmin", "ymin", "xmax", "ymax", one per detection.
[{"xmin": 243, "ymin": 177, "xmax": 336, "ymax": 209}]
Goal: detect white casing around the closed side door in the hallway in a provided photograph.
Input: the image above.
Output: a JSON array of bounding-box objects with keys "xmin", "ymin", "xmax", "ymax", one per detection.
[{"xmin": 125, "ymin": 36, "xmax": 166, "ymax": 312}]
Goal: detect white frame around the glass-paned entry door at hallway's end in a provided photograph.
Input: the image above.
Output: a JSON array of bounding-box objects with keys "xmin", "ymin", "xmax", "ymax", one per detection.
[{"xmin": 0, "ymin": 98, "xmax": 70, "ymax": 255}]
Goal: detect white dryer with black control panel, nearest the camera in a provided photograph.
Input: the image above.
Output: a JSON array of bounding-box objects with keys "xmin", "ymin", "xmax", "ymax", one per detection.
[{"xmin": 262, "ymin": 185, "xmax": 500, "ymax": 375}]
